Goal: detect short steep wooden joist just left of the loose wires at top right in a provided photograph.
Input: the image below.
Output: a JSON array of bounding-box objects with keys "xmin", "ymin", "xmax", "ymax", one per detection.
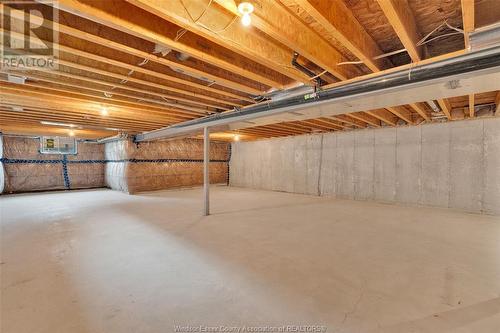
[{"xmin": 377, "ymin": 0, "xmax": 423, "ymax": 62}]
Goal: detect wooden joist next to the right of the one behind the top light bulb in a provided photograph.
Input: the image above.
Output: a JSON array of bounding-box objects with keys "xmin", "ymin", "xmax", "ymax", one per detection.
[{"xmin": 292, "ymin": 0, "xmax": 391, "ymax": 72}]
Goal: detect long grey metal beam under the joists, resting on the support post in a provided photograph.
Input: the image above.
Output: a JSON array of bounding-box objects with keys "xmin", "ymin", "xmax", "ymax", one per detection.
[{"xmin": 135, "ymin": 46, "xmax": 500, "ymax": 142}]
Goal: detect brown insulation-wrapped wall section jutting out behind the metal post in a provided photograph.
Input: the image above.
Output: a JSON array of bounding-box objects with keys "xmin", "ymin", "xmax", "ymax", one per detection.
[{"xmin": 105, "ymin": 139, "xmax": 230, "ymax": 193}]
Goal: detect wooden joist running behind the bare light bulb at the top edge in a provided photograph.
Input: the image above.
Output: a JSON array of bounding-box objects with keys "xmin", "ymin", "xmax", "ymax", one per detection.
[{"xmin": 213, "ymin": 0, "xmax": 358, "ymax": 80}]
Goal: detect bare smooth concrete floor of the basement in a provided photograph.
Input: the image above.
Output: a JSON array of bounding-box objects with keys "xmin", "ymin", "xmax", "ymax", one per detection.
[{"xmin": 0, "ymin": 187, "xmax": 500, "ymax": 333}]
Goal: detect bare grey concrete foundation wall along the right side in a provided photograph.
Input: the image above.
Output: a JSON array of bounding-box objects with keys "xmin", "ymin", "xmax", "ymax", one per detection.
[{"xmin": 230, "ymin": 118, "xmax": 500, "ymax": 214}]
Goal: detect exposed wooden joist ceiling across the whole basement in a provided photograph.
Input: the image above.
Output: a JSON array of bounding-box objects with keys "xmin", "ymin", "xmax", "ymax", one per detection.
[{"xmin": 0, "ymin": 0, "xmax": 500, "ymax": 140}]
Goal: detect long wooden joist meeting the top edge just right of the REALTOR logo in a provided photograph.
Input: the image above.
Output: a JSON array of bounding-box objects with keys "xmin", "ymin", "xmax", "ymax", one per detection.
[{"xmin": 56, "ymin": 0, "xmax": 289, "ymax": 89}]
